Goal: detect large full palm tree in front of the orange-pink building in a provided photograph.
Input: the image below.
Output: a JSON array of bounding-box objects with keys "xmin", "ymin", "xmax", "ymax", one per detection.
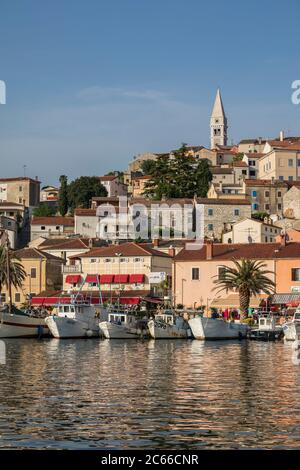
[{"xmin": 214, "ymin": 258, "xmax": 275, "ymax": 318}]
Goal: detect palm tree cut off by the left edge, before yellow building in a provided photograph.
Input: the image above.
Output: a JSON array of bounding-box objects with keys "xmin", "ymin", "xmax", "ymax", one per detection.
[{"xmin": 0, "ymin": 243, "xmax": 26, "ymax": 310}]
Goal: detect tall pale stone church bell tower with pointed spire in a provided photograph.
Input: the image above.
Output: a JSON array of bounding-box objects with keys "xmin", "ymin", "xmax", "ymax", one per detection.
[{"xmin": 210, "ymin": 88, "xmax": 227, "ymax": 149}]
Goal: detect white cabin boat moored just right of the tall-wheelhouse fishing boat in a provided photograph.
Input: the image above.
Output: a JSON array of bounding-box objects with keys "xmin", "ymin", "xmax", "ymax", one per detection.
[{"xmin": 99, "ymin": 311, "xmax": 149, "ymax": 339}]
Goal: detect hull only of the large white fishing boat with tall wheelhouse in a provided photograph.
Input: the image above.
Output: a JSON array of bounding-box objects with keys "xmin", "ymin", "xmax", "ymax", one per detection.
[{"xmin": 46, "ymin": 315, "xmax": 99, "ymax": 338}]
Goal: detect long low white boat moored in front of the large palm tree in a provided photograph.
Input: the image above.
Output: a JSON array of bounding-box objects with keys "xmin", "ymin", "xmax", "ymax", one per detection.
[{"xmin": 189, "ymin": 315, "xmax": 248, "ymax": 340}]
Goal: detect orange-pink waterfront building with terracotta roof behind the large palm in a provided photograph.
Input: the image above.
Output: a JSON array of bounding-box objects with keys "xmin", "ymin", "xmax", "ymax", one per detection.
[{"xmin": 173, "ymin": 238, "xmax": 300, "ymax": 308}]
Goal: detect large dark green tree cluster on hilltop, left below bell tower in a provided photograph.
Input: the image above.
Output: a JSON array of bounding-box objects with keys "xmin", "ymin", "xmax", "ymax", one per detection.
[{"xmin": 144, "ymin": 144, "xmax": 212, "ymax": 196}]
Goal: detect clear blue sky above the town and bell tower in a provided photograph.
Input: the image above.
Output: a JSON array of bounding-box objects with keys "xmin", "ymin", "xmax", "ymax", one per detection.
[{"xmin": 0, "ymin": 0, "xmax": 300, "ymax": 184}]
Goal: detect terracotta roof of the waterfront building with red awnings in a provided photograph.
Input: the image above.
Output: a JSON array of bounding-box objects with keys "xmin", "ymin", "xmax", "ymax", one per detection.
[{"xmin": 75, "ymin": 242, "xmax": 170, "ymax": 258}]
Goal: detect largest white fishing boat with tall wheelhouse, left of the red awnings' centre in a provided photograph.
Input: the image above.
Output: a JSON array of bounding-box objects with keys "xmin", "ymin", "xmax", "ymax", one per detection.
[{"xmin": 46, "ymin": 301, "xmax": 107, "ymax": 338}]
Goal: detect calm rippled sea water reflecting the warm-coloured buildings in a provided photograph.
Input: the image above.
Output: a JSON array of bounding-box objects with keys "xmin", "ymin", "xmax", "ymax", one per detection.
[{"xmin": 0, "ymin": 339, "xmax": 300, "ymax": 449}]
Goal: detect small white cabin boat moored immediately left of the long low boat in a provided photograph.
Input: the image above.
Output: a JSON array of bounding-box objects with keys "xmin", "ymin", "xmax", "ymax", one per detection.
[{"xmin": 148, "ymin": 311, "xmax": 192, "ymax": 339}]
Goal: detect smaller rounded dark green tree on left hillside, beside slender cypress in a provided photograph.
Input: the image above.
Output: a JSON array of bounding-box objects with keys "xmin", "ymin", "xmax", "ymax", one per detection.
[{"xmin": 68, "ymin": 176, "xmax": 107, "ymax": 209}]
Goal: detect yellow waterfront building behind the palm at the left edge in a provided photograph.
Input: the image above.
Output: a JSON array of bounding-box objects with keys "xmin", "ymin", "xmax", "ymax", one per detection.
[{"xmin": 1, "ymin": 248, "xmax": 63, "ymax": 307}]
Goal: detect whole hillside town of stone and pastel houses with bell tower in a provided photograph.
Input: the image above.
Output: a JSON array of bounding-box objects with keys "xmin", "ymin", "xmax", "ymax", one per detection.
[{"xmin": 0, "ymin": 90, "xmax": 300, "ymax": 315}]
